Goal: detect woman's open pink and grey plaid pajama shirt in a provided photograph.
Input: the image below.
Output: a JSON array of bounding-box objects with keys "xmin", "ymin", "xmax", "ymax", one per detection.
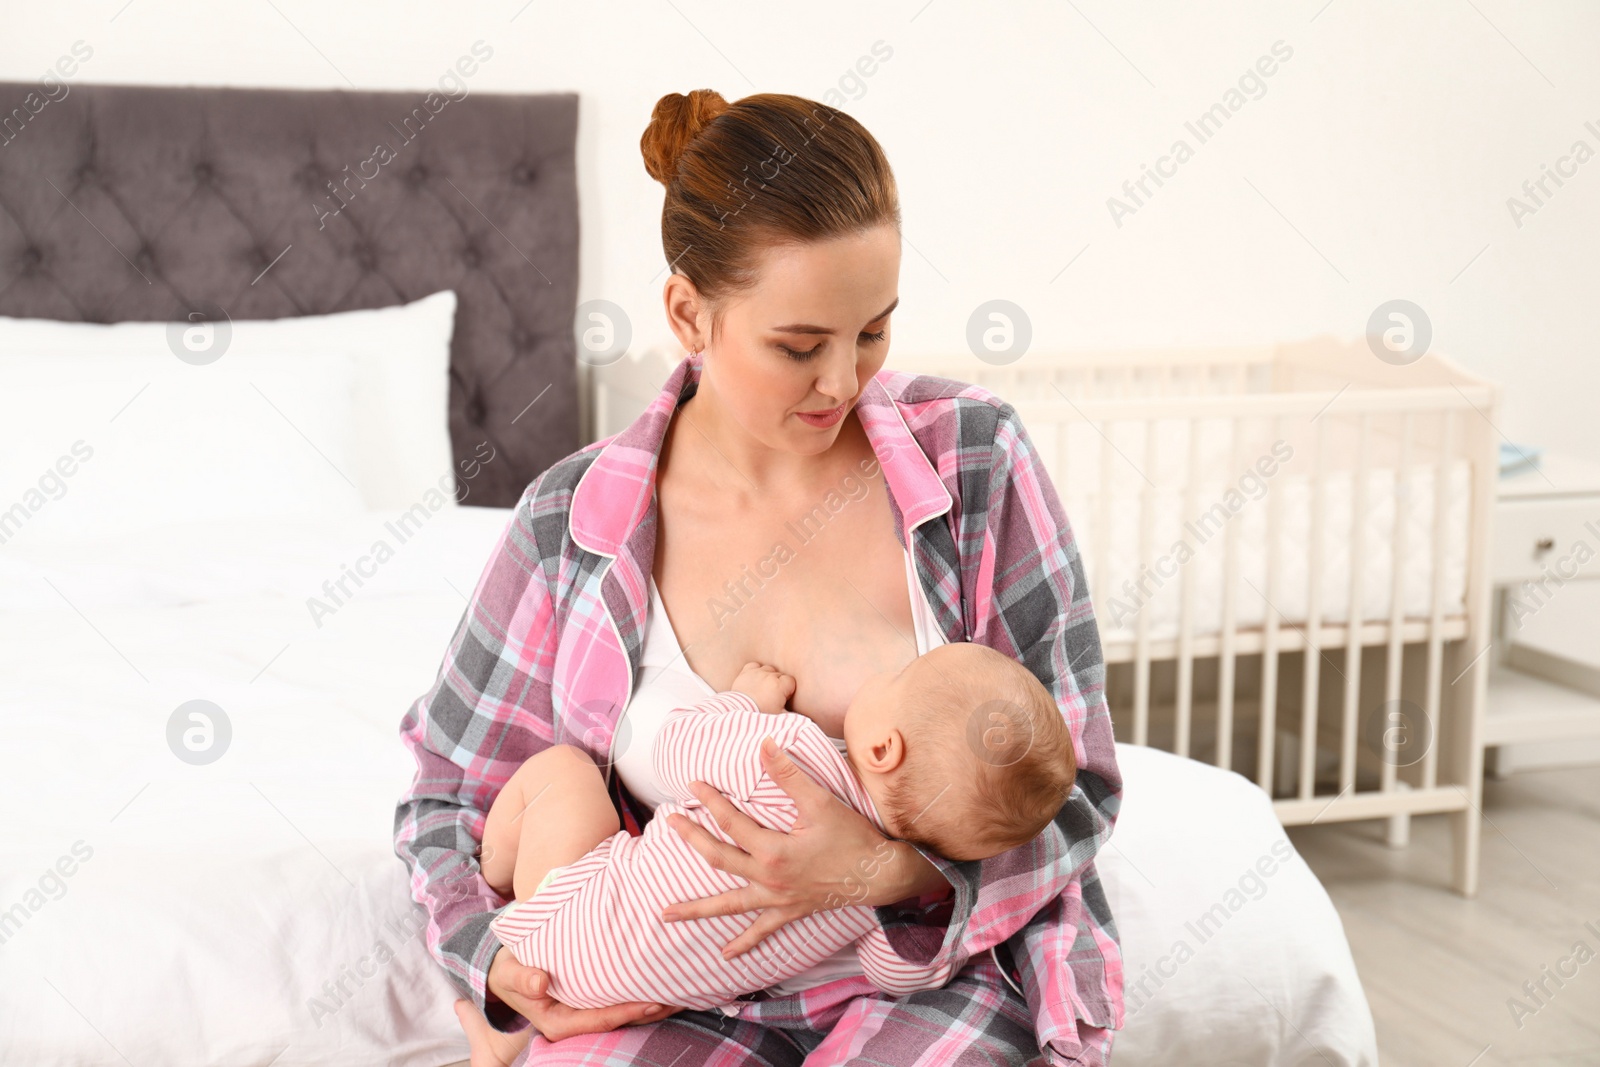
[{"xmin": 395, "ymin": 355, "xmax": 1123, "ymax": 1067}]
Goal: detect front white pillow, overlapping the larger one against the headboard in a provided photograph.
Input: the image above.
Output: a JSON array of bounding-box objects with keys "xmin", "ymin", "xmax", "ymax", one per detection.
[{"xmin": 0, "ymin": 347, "xmax": 362, "ymax": 542}]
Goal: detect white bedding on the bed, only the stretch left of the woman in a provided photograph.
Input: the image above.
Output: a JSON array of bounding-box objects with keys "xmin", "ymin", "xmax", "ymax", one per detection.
[{"xmin": 0, "ymin": 507, "xmax": 510, "ymax": 1067}]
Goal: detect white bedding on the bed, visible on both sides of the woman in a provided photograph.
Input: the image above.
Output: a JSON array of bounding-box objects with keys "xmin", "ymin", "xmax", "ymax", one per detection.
[{"xmin": 0, "ymin": 507, "xmax": 1374, "ymax": 1067}]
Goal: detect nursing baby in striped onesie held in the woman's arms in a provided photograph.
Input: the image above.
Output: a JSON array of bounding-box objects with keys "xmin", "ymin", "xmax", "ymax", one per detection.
[{"xmin": 458, "ymin": 641, "xmax": 1077, "ymax": 1067}]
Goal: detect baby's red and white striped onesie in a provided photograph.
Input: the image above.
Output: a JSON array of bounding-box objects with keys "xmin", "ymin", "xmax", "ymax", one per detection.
[{"xmin": 490, "ymin": 693, "xmax": 954, "ymax": 1011}]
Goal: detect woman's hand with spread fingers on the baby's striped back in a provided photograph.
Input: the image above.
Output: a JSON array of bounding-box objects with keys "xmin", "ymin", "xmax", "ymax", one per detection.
[{"xmin": 661, "ymin": 737, "xmax": 949, "ymax": 960}]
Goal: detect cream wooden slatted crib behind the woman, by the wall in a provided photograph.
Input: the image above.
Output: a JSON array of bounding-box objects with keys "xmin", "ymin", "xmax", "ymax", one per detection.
[{"xmin": 891, "ymin": 338, "xmax": 1499, "ymax": 896}]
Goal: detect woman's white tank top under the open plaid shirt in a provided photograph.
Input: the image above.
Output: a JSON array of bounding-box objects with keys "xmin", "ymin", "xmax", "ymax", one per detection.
[{"xmin": 611, "ymin": 552, "xmax": 946, "ymax": 995}]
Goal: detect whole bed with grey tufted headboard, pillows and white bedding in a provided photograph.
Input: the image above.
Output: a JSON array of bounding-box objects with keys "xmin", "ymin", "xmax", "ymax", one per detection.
[{"xmin": 0, "ymin": 86, "xmax": 1376, "ymax": 1067}]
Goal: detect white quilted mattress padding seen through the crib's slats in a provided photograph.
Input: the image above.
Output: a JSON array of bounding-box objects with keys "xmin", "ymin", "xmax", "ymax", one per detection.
[{"xmin": 1062, "ymin": 461, "xmax": 1472, "ymax": 641}]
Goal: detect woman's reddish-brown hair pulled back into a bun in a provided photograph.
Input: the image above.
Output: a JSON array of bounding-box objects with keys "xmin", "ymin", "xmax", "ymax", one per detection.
[{"xmin": 638, "ymin": 90, "xmax": 901, "ymax": 338}]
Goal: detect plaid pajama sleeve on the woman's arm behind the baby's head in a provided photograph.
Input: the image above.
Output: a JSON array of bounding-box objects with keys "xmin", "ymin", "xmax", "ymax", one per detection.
[{"xmin": 915, "ymin": 405, "xmax": 1123, "ymax": 1067}]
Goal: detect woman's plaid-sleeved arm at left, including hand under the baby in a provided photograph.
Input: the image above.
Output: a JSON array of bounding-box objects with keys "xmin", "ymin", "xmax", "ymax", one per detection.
[{"xmin": 395, "ymin": 482, "xmax": 675, "ymax": 1040}]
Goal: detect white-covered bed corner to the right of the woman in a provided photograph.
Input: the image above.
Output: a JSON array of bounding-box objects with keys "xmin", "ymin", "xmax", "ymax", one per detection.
[{"xmin": 1096, "ymin": 744, "xmax": 1378, "ymax": 1067}]
